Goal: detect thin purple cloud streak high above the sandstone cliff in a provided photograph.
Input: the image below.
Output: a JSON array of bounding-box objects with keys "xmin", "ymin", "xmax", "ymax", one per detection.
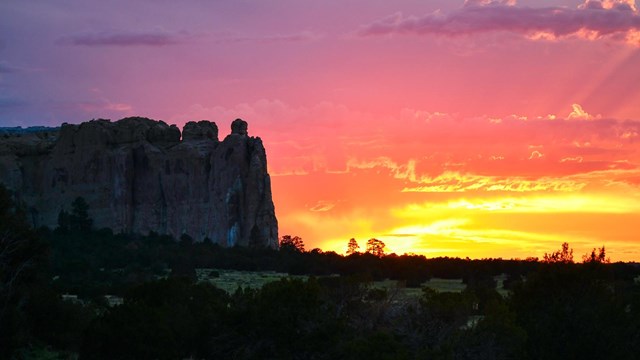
[{"xmin": 58, "ymin": 31, "xmax": 185, "ymax": 46}]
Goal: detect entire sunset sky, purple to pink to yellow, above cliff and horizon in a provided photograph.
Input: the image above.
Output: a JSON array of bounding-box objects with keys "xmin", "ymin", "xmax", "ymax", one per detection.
[{"xmin": 0, "ymin": 0, "xmax": 640, "ymax": 261}]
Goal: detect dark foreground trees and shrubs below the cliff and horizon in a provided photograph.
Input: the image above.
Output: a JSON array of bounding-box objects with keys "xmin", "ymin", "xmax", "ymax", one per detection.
[{"xmin": 0, "ymin": 188, "xmax": 640, "ymax": 360}]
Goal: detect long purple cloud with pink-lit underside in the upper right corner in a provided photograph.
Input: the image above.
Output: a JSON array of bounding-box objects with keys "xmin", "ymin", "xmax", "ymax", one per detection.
[{"xmin": 358, "ymin": 0, "xmax": 640, "ymax": 45}]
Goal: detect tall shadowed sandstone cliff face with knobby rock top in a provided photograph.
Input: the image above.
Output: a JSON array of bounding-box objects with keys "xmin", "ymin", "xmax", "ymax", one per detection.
[{"xmin": 0, "ymin": 118, "xmax": 278, "ymax": 247}]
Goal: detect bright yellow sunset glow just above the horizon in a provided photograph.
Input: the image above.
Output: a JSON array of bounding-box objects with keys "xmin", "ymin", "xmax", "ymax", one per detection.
[{"xmin": 288, "ymin": 188, "xmax": 640, "ymax": 259}]
